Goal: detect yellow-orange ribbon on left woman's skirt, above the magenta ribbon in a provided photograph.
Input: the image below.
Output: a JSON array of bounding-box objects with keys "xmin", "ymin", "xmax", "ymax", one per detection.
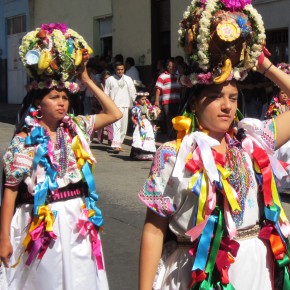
[{"xmin": 23, "ymin": 205, "xmax": 54, "ymax": 247}]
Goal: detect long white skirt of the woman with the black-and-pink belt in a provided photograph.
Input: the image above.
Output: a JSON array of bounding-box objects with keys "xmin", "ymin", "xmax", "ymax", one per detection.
[{"xmin": 6, "ymin": 198, "xmax": 109, "ymax": 290}]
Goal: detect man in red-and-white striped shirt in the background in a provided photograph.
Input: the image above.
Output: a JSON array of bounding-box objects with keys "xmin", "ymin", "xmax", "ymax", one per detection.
[{"xmin": 154, "ymin": 59, "xmax": 181, "ymax": 138}]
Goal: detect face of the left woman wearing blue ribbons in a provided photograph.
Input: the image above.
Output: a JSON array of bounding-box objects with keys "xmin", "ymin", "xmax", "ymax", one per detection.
[{"xmin": 37, "ymin": 89, "xmax": 69, "ymax": 122}]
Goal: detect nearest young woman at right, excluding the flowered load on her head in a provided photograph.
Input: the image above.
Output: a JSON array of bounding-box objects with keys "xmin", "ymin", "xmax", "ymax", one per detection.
[{"xmin": 139, "ymin": 58, "xmax": 290, "ymax": 290}]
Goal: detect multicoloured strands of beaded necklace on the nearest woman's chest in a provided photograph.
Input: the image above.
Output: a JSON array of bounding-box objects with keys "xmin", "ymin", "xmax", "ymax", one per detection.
[{"xmin": 225, "ymin": 135, "xmax": 250, "ymax": 226}]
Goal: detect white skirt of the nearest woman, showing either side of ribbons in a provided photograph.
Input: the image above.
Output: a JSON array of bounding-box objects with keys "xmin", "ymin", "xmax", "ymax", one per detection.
[{"xmin": 153, "ymin": 238, "xmax": 273, "ymax": 290}]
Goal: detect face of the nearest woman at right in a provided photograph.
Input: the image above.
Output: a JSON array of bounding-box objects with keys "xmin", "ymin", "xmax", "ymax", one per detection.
[{"xmin": 193, "ymin": 82, "xmax": 238, "ymax": 139}]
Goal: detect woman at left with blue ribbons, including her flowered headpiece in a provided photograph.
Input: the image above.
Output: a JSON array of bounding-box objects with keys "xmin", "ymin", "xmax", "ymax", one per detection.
[{"xmin": 0, "ymin": 23, "xmax": 122, "ymax": 290}]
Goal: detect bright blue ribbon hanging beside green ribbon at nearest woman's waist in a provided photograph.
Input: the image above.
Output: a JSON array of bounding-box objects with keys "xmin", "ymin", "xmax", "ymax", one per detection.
[{"xmin": 192, "ymin": 215, "xmax": 218, "ymax": 271}]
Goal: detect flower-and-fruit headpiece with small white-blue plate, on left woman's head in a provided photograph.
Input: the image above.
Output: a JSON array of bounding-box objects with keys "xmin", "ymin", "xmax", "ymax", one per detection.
[{"xmin": 19, "ymin": 23, "xmax": 92, "ymax": 93}]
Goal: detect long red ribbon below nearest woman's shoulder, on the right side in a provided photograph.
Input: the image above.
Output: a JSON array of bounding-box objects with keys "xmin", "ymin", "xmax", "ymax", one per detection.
[{"xmin": 253, "ymin": 147, "xmax": 273, "ymax": 206}]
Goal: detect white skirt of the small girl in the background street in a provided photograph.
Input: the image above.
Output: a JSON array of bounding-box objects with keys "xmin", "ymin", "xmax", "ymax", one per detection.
[{"xmin": 132, "ymin": 119, "xmax": 156, "ymax": 153}]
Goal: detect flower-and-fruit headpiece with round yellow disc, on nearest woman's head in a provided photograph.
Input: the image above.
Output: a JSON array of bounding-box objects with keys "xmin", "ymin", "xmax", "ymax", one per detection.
[{"xmin": 178, "ymin": 0, "xmax": 266, "ymax": 86}]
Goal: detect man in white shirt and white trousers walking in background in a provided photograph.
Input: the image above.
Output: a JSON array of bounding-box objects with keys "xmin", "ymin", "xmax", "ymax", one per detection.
[{"xmin": 105, "ymin": 62, "xmax": 136, "ymax": 153}]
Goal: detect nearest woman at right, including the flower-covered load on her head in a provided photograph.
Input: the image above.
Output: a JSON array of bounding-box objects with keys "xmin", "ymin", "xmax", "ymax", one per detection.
[{"xmin": 139, "ymin": 0, "xmax": 290, "ymax": 290}]
